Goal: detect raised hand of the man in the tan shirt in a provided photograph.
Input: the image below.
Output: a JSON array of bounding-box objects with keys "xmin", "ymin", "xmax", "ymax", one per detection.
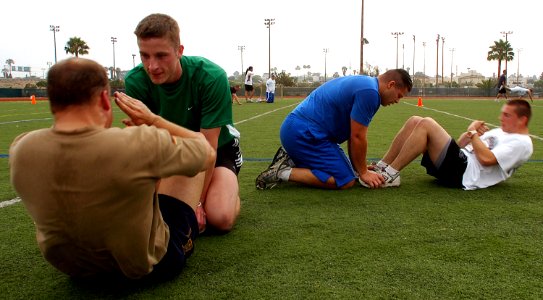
[{"xmin": 113, "ymin": 92, "xmax": 160, "ymax": 126}]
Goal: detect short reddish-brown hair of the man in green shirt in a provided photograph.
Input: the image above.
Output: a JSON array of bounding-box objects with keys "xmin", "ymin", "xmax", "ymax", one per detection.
[{"xmin": 134, "ymin": 14, "xmax": 181, "ymax": 48}]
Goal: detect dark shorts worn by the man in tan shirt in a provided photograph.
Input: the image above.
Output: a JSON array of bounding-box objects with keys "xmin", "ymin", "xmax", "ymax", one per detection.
[{"xmin": 151, "ymin": 194, "xmax": 199, "ymax": 276}]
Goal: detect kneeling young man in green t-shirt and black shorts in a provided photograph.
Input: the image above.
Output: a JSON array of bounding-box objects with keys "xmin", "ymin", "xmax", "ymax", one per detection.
[{"xmin": 125, "ymin": 14, "xmax": 243, "ymax": 231}]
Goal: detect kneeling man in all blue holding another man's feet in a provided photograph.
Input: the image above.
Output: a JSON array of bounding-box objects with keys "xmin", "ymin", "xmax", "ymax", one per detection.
[{"xmin": 256, "ymin": 69, "xmax": 413, "ymax": 189}]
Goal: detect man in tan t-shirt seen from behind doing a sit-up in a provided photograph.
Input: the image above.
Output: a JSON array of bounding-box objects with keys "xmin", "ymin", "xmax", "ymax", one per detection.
[{"xmin": 9, "ymin": 58, "xmax": 216, "ymax": 278}]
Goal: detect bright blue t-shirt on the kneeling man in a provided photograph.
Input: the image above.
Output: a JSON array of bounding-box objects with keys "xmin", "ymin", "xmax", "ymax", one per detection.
[{"xmin": 292, "ymin": 75, "xmax": 381, "ymax": 144}]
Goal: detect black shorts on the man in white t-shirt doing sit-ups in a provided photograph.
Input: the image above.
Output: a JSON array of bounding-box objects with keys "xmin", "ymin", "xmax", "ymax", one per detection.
[{"xmin": 420, "ymin": 139, "xmax": 468, "ymax": 188}]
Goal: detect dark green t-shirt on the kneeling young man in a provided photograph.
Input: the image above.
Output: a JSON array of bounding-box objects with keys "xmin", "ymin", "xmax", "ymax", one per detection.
[{"xmin": 125, "ymin": 56, "xmax": 239, "ymax": 147}]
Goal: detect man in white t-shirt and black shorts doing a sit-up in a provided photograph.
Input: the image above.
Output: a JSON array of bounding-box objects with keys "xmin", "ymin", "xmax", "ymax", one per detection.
[{"xmin": 371, "ymin": 99, "xmax": 533, "ymax": 190}]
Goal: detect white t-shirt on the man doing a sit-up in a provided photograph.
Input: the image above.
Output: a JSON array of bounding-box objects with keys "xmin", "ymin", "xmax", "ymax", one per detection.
[{"xmin": 462, "ymin": 128, "xmax": 534, "ymax": 190}]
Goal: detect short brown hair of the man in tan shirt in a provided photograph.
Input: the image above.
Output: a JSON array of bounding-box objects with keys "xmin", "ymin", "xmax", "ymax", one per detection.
[{"xmin": 47, "ymin": 57, "xmax": 109, "ymax": 113}]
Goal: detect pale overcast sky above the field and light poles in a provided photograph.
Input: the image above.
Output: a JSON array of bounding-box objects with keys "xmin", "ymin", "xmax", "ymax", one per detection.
[{"xmin": 0, "ymin": 0, "xmax": 543, "ymax": 77}]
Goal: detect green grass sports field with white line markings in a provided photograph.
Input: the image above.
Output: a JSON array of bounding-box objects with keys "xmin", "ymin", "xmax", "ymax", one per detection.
[{"xmin": 0, "ymin": 98, "xmax": 543, "ymax": 299}]
